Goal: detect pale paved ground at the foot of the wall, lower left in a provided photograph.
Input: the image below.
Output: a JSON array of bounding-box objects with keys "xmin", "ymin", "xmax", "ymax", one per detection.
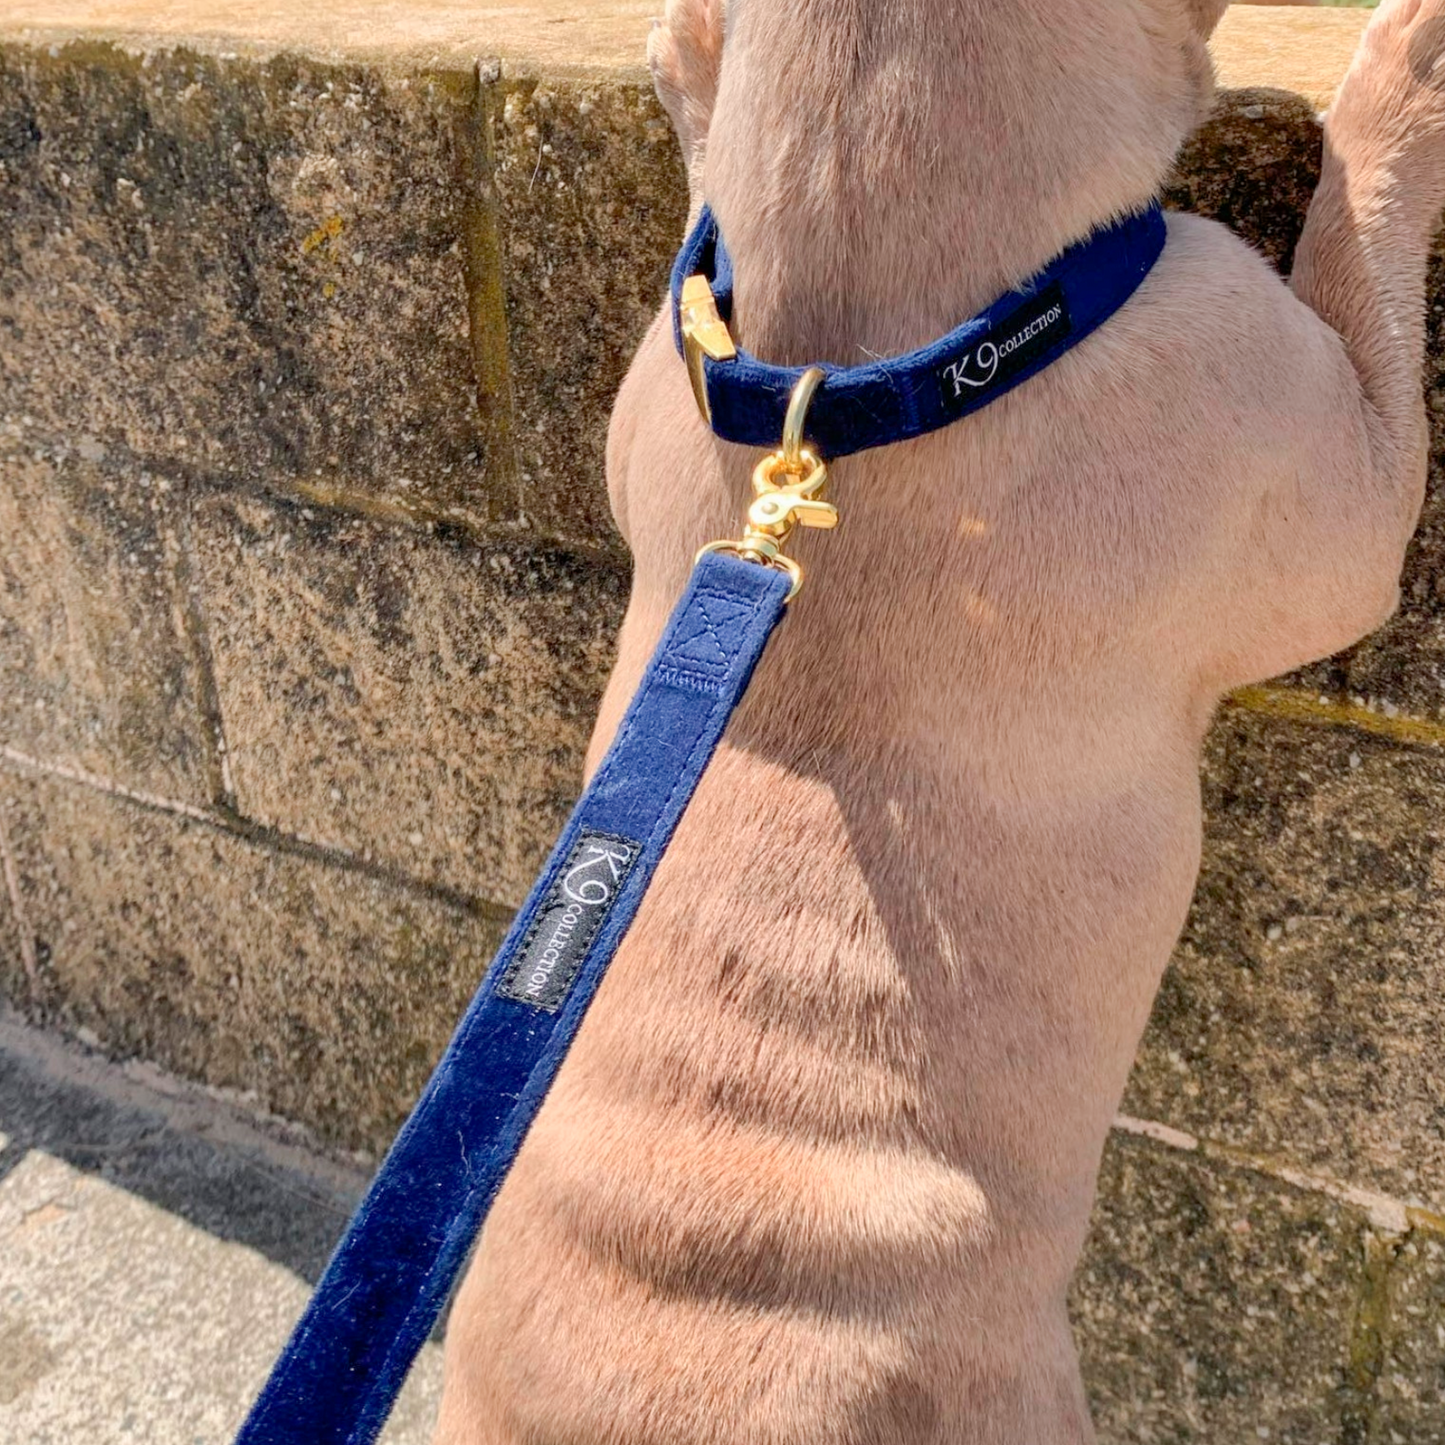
[{"xmin": 0, "ymin": 1017, "xmax": 441, "ymax": 1445}]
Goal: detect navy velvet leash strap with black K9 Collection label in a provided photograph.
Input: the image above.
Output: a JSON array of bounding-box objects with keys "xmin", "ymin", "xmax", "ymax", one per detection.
[{"xmin": 237, "ymin": 553, "xmax": 789, "ymax": 1445}]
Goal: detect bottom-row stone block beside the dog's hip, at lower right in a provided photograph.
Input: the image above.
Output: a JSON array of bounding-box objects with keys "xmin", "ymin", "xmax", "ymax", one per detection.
[{"xmin": 1072, "ymin": 1133, "xmax": 1369, "ymax": 1445}]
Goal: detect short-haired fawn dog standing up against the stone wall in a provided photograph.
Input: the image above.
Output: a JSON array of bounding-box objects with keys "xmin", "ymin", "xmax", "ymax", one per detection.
[{"xmin": 436, "ymin": 0, "xmax": 1445, "ymax": 1445}]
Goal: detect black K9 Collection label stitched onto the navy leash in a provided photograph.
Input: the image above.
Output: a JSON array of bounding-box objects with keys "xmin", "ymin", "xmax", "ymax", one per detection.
[{"xmin": 497, "ymin": 831, "xmax": 642, "ymax": 1013}]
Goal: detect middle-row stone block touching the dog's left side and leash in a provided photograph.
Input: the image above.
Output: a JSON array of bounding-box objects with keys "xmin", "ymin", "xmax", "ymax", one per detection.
[{"xmin": 187, "ymin": 496, "xmax": 626, "ymax": 903}]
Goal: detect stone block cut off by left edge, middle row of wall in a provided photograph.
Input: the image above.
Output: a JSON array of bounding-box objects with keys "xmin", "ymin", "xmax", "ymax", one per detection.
[{"xmin": 0, "ymin": 425, "xmax": 220, "ymax": 803}]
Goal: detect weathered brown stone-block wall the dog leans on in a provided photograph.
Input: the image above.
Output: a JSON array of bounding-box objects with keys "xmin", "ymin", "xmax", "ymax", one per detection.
[{"xmin": 0, "ymin": 0, "xmax": 1445, "ymax": 1445}]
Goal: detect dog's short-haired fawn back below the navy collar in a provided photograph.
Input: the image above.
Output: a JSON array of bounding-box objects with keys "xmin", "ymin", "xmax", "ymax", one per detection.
[{"xmin": 433, "ymin": 218, "xmax": 1389, "ymax": 1445}]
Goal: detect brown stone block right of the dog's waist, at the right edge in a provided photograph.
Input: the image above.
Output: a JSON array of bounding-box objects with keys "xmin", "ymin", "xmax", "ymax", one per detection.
[{"xmin": 1124, "ymin": 711, "xmax": 1445, "ymax": 1209}]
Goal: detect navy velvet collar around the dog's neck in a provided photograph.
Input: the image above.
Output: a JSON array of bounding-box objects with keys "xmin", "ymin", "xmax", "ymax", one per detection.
[{"xmin": 672, "ymin": 205, "xmax": 1165, "ymax": 461}]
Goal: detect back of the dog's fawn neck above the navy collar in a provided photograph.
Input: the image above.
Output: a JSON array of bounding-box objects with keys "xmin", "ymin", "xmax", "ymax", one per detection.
[{"xmin": 704, "ymin": 0, "xmax": 1212, "ymax": 364}]
